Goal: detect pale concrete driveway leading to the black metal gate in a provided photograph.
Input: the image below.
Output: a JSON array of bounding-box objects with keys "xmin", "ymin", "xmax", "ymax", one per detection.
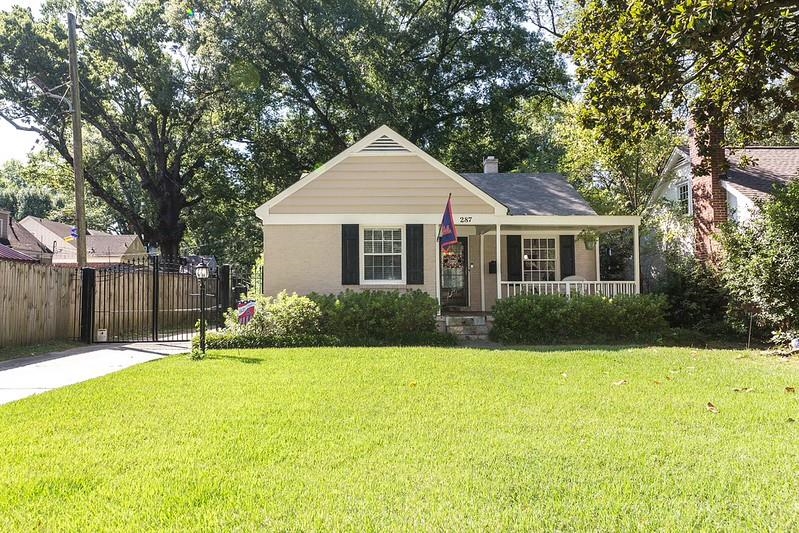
[{"xmin": 0, "ymin": 342, "xmax": 189, "ymax": 405}]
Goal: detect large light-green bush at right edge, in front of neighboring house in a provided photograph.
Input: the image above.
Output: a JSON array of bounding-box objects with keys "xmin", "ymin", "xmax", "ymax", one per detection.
[{"xmin": 721, "ymin": 181, "xmax": 799, "ymax": 342}]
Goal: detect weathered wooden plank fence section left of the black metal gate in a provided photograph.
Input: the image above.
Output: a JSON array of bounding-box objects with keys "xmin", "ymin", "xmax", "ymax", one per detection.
[{"xmin": 0, "ymin": 261, "xmax": 81, "ymax": 346}]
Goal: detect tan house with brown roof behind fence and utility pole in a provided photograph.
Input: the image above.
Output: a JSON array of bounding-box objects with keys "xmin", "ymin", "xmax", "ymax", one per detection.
[{"xmin": 19, "ymin": 216, "xmax": 147, "ymax": 266}]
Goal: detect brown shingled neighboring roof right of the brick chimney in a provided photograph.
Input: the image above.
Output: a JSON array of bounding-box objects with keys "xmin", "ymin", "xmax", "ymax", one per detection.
[{"xmin": 725, "ymin": 146, "xmax": 799, "ymax": 200}]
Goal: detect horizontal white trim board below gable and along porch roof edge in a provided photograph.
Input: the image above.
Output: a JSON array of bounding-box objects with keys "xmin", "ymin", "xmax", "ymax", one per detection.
[{"xmin": 263, "ymin": 213, "xmax": 641, "ymax": 227}]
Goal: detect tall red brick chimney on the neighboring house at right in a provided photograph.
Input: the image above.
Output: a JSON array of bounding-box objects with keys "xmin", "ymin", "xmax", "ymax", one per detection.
[{"xmin": 688, "ymin": 113, "xmax": 727, "ymax": 262}]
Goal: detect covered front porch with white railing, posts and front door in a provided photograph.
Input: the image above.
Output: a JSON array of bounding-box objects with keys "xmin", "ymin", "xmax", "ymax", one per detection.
[{"xmin": 436, "ymin": 216, "xmax": 640, "ymax": 314}]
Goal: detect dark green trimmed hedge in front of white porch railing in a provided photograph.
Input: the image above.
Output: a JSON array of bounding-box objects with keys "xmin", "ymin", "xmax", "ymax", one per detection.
[{"xmin": 490, "ymin": 295, "xmax": 668, "ymax": 344}]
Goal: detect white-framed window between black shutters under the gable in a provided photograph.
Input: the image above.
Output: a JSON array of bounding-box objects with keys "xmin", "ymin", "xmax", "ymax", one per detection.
[{"xmin": 361, "ymin": 226, "xmax": 405, "ymax": 285}]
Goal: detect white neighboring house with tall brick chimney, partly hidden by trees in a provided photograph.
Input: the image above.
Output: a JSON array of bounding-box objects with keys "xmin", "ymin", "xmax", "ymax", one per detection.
[{"xmin": 650, "ymin": 123, "xmax": 799, "ymax": 260}]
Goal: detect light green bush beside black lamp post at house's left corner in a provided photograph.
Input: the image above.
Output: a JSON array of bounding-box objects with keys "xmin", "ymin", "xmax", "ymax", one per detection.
[{"xmin": 225, "ymin": 291, "xmax": 321, "ymax": 337}]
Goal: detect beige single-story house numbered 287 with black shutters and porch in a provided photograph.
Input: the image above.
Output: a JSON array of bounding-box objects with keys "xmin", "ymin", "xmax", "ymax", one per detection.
[{"xmin": 256, "ymin": 126, "xmax": 640, "ymax": 312}]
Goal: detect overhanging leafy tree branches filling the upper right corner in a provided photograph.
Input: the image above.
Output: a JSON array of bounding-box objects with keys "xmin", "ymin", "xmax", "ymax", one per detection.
[{"xmin": 560, "ymin": 0, "xmax": 799, "ymax": 145}]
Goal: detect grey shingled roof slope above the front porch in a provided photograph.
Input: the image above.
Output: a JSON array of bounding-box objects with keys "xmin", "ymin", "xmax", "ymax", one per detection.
[{"xmin": 461, "ymin": 172, "xmax": 596, "ymax": 216}]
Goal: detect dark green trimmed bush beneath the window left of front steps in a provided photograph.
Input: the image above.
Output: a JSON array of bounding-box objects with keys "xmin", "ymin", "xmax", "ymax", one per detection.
[{"xmin": 309, "ymin": 290, "xmax": 454, "ymax": 345}]
